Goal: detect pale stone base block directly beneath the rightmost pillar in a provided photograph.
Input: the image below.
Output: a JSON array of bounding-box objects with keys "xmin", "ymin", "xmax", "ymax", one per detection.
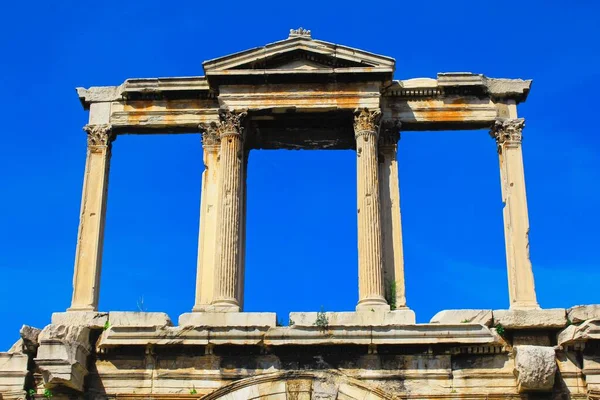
[{"xmin": 493, "ymin": 308, "xmax": 567, "ymax": 329}]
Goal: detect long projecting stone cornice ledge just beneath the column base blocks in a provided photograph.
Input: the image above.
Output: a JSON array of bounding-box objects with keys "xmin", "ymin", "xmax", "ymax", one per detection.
[{"xmin": 97, "ymin": 324, "xmax": 499, "ymax": 350}]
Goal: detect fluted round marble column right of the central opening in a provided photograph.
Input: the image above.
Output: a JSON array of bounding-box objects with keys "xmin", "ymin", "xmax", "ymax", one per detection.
[{"xmin": 354, "ymin": 109, "xmax": 390, "ymax": 311}]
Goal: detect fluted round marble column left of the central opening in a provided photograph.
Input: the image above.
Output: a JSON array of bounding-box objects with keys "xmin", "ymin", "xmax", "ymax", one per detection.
[{"xmin": 212, "ymin": 111, "xmax": 246, "ymax": 312}]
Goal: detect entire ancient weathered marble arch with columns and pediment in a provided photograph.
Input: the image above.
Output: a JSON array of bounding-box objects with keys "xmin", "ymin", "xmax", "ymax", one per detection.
[{"xmin": 0, "ymin": 28, "xmax": 600, "ymax": 400}]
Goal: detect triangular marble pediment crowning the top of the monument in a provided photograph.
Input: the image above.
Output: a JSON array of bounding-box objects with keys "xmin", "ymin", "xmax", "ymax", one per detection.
[{"xmin": 203, "ymin": 31, "xmax": 395, "ymax": 79}]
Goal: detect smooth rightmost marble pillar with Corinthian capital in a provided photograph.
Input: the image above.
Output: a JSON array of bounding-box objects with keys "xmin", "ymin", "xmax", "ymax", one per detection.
[{"xmin": 490, "ymin": 118, "xmax": 539, "ymax": 309}]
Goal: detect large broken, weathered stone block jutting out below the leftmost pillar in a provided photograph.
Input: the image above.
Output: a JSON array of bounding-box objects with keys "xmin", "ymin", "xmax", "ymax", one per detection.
[{"xmin": 35, "ymin": 325, "xmax": 90, "ymax": 392}]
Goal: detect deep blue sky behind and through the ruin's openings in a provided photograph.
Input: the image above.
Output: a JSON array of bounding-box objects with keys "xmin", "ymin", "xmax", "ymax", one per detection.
[{"xmin": 0, "ymin": 0, "xmax": 600, "ymax": 349}]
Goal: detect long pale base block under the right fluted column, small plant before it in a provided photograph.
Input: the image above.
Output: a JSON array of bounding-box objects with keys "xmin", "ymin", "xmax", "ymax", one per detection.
[{"xmin": 290, "ymin": 310, "xmax": 415, "ymax": 327}]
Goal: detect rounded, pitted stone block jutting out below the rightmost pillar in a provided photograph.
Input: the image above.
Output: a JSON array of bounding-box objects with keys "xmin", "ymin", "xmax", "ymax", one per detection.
[{"xmin": 514, "ymin": 346, "xmax": 557, "ymax": 393}]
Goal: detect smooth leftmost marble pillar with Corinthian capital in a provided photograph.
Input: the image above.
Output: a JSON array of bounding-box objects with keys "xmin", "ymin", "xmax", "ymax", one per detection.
[{"xmin": 67, "ymin": 124, "xmax": 115, "ymax": 311}]
